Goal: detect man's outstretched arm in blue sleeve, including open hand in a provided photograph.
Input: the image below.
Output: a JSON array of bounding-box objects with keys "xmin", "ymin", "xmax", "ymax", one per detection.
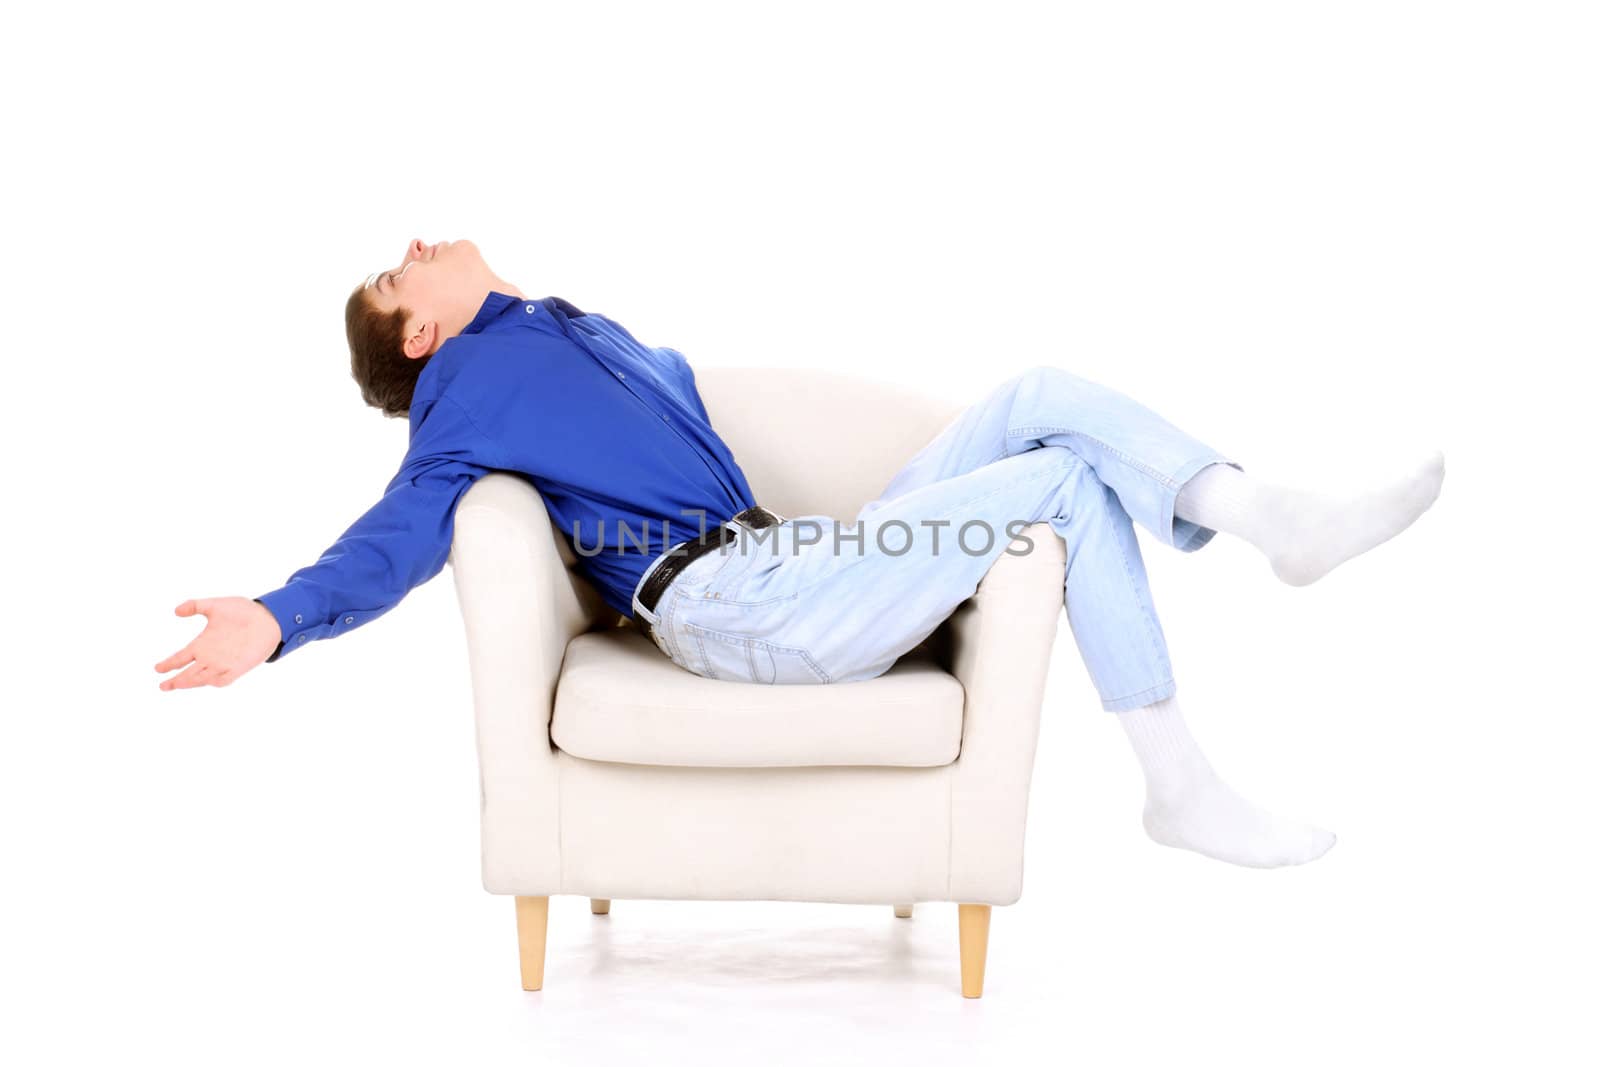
[{"xmin": 155, "ymin": 397, "xmax": 496, "ymax": 689}]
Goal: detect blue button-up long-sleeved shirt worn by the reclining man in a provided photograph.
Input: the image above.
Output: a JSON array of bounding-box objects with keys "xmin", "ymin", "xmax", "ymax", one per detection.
[{"xmin": 256, "ymin": 293, "xmax": 755, "ymax": 662}]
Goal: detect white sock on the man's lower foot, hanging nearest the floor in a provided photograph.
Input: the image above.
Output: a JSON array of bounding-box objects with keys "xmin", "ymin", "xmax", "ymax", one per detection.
[{"xmin": 1114, "ymin": 696, "xmax": 1338, "ymax": 867}]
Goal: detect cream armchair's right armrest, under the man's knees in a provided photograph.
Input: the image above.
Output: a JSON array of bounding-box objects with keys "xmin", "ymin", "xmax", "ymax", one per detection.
[{"xmin": 934, "ymin": 523, "xmax": 1067, "ymax": 904}]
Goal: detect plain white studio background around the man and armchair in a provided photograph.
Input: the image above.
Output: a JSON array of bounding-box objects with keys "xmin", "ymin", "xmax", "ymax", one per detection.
[{"xmin": 0, "ymin": 2, "xmax": 1600, "ymax": 1064}]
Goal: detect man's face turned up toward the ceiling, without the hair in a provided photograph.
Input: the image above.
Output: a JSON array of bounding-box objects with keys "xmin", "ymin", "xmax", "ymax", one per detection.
[{"xmin": 363, "ymin": 238, "xmax": 494, "ymax": 358}]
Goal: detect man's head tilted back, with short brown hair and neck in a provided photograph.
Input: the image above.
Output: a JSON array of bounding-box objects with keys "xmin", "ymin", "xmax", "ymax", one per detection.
[{"xmin": 344, "ymin": 240, "xmax": 522, "ymax": 416}]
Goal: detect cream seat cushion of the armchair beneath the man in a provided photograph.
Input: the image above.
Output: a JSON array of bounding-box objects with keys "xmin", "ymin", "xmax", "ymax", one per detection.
[{"xmin": 550, "ymin": 625, "xmax": 965, "ymax": 766}]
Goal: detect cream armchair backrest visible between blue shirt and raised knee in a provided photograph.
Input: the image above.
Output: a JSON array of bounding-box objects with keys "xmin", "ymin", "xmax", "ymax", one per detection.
[{"xmin": 694, "ymin": 366, "xmax": 960, "ymax": 522}]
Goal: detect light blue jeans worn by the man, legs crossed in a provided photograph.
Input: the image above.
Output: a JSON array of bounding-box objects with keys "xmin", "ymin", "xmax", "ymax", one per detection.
[{"xmin": 634, "ymin": 366, "xmax": 1243, "ymax": 712}]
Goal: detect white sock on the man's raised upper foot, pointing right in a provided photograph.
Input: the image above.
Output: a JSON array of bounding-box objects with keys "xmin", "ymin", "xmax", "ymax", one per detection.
[{"xmin": 1176, "ymin": 451, "xmax": 1445, "ymax": 585}]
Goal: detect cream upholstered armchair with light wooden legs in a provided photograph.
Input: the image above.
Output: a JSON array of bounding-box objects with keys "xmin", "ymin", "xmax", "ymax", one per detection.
[{"xmin": 450, "ymin": 368, "xmax": 1066, "ymax": 997}]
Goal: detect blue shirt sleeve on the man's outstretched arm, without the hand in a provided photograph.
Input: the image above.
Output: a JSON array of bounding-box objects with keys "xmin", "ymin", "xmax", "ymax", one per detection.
[{"xmin": 254, "ymin": 395, "xmax": 494, "ymax": 664}]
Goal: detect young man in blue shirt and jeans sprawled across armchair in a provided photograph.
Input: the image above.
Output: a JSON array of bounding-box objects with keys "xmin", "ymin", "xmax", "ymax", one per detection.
[{"xmin": 155, "ymin": 240, "xmax": 1445, "ymax": 867}]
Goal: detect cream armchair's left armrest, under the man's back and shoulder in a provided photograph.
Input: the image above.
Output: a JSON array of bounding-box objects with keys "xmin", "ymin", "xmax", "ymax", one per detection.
[{"xmin": 450, "ymin": 472, "xmax": 618, "ymax": 896}]
